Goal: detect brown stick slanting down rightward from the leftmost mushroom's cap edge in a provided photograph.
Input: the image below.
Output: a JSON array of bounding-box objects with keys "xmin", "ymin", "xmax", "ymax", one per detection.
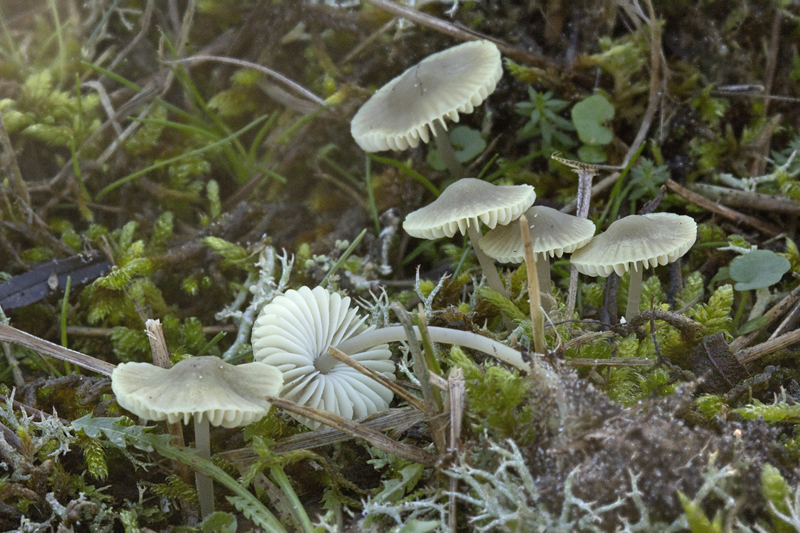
[{"xmin": 265, "ymin": 396, "xmax": 436, "ymax": 466}]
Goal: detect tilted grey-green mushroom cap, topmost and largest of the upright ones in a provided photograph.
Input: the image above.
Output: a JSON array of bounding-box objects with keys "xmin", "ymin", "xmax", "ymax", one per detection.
[{"xmin": 350, "ymin": 41, "xmax": 503, "ymax": 152}]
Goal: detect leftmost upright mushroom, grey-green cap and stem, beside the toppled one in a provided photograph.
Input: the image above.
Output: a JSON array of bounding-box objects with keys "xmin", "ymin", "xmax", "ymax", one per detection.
[{"xmin": 111, "ymin": 356, "xmax": 283, "ymax": 518}]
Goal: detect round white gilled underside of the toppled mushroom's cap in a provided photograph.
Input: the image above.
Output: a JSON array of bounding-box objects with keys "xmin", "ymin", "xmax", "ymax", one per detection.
[{"xmin": 252, "ymin": 287, "xmax": 394, "ymax": 429}]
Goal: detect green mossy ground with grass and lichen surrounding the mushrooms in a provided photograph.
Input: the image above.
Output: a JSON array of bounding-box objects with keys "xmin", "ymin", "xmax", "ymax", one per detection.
[{"xmin": 0, "ymin": 0, "xmax": 800, "ymax": 532}]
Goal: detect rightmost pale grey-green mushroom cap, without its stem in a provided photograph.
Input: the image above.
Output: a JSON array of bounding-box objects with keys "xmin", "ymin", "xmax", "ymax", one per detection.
[{"xmin": 571, "ymin": 213, "xmax": 697, "ymax": 277}]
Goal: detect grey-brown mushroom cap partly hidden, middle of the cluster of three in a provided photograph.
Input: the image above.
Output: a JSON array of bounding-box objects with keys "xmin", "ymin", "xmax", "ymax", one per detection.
[{"xmin": 479, "ymin": 205, "xmax": 594, "ymax": 263}]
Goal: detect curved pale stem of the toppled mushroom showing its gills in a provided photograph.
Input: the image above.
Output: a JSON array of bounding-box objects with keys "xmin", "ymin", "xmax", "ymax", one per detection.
[{"xmin": 332, "ymin": 326, "xmax": 531, "ymax": 372}]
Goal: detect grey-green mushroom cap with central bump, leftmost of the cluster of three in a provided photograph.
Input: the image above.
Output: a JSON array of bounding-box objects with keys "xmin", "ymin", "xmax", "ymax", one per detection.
[{"xmin": 403, "ymin": 178, "xmax": 536, "ymax": 239}]
